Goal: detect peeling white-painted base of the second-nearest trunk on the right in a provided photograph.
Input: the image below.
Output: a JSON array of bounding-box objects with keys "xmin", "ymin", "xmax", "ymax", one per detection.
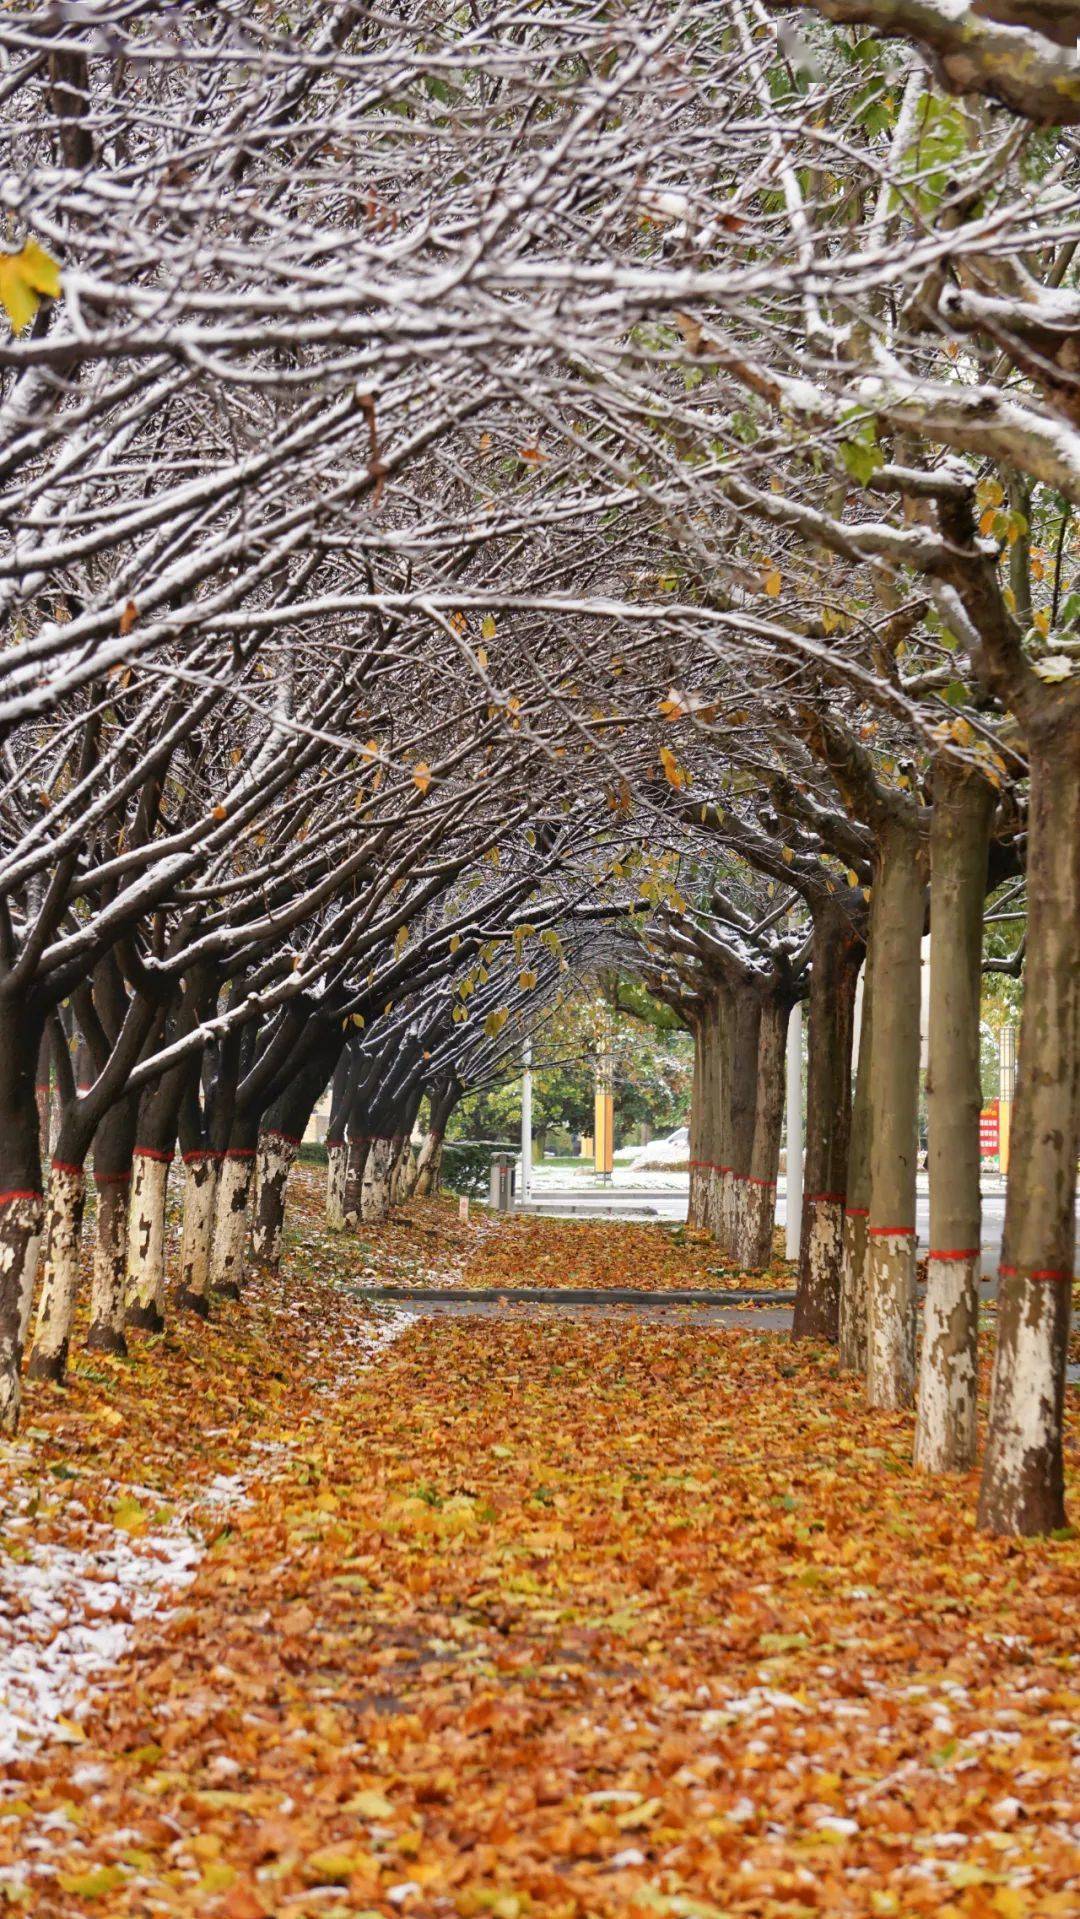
[{"xmin": 915, "ymin": 1253, "xmax": 980, "ymax": 1472}]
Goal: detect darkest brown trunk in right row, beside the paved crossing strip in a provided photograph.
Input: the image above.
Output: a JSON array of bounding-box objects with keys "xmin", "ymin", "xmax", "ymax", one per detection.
[{"xmin": 792, "ymin": 900, "xmax": 863, "ymax": 1339}]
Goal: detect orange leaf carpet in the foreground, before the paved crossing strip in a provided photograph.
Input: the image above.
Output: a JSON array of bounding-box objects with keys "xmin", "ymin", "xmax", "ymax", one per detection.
[{"xmin": 0, "ymin": 1189, "xmax": 1080, "ymax": 1919}]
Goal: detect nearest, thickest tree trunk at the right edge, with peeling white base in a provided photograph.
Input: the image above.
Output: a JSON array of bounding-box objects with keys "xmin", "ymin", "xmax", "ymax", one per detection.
[{"xmin": 978, "ymin": 700, "xmax": 1080, "ymax": 1533}]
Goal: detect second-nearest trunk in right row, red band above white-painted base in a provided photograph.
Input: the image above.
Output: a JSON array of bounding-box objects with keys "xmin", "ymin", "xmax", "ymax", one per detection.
[{"xmin": 915, "ymin": 758, "xmax": 996, "ymax": 1472}]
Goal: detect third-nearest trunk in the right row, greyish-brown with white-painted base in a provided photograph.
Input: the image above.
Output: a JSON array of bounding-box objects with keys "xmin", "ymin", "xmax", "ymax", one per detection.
[{"xmin": 867, "ymin": 819, "xmax": 925, "ymax": 1407}]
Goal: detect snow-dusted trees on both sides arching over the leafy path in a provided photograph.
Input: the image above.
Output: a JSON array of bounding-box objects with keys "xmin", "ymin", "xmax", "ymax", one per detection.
[{"xmin": 0, "ymin": 0, "xmax": 1080, "ymax": 1529}]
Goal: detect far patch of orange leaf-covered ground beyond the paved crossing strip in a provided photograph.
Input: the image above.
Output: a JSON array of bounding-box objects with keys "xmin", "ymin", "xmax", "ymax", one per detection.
[{"xmin": 290, "ymin": 1165, "xmax": 794, "ymax": 1291}]
